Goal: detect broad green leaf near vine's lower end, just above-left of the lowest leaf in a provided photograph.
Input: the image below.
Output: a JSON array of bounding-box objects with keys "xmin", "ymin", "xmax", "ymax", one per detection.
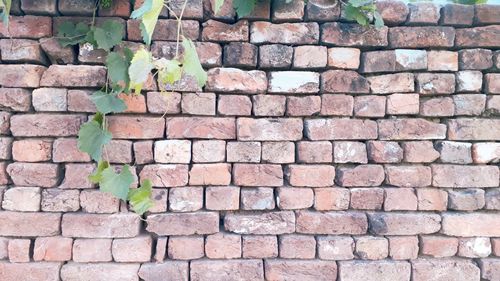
[{"xmin": 99, "ymin": 165, "xmax": 134, "ymax": 201}]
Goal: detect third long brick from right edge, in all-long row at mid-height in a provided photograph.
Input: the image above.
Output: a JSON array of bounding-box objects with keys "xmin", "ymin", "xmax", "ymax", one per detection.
[{"xmin": 304, "ymin": 119, "xmax": 377, "ymax": 140}]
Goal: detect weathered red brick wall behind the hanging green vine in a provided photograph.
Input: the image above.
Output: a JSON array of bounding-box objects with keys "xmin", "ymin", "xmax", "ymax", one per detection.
[{"xmin": 0, "ymin": 0, "xmax": 500, "ymax": 281}]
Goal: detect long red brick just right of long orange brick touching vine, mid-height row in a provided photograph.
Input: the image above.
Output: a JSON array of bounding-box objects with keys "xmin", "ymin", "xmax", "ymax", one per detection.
[{"xmin": 167, "ymin": 117, "xmax": 236, "ymax": 139}]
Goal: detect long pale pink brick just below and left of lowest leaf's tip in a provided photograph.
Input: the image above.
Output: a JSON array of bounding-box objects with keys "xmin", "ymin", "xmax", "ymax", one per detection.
[{"xmin": 61, "ymin": 213, "xmax": 141, "ymax": 238}]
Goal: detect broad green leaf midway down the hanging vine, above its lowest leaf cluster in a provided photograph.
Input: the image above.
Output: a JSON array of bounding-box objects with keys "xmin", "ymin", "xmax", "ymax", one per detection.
[{"xmin": 78, "ymin": 113, "xmax": 112, "ymax": 161}]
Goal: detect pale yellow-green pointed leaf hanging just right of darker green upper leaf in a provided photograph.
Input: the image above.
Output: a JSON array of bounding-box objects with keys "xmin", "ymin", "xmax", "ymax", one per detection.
[{"xmin": 128, "ymin": 48, "xmax": 154, "ymax": 94}]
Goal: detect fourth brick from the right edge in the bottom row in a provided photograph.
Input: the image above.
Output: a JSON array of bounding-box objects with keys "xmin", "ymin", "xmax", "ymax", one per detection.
[{"xmin": 265, "ymin": 260, "xmax": 337, "ymax": 281}]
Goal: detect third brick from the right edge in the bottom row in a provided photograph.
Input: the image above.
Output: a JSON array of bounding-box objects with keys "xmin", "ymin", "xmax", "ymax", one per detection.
[{"xmin": 339, "ymin": 260, "xmax": 411, "ymax": 281}]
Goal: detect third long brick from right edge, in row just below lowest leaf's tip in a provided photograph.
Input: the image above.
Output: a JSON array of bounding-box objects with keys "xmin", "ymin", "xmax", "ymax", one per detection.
[{"xmin": 297, "ymin": 211, "xmax": 368, "ymax": 235}]
